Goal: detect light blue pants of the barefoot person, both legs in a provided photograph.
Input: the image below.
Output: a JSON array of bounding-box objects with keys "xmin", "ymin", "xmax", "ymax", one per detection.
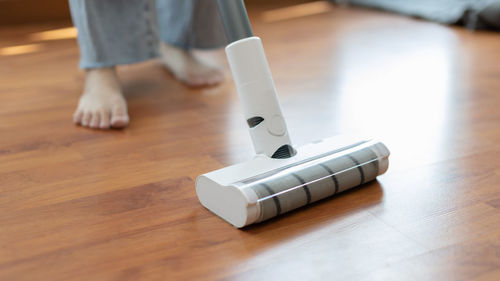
[{"xmin": 69, "ymin": 0, "xmax": 227, "ymax": 69}]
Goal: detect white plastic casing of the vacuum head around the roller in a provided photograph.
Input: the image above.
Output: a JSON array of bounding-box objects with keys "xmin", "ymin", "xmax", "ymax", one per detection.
[{"xmin": 196, "ymin": 137, "xmax": 389, "ymax": 228}]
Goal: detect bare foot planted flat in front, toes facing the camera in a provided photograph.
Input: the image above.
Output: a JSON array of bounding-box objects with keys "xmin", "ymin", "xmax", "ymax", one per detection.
[{"xmin": 73, "ymin": 67, "xmax": 129, "ymax": 129}]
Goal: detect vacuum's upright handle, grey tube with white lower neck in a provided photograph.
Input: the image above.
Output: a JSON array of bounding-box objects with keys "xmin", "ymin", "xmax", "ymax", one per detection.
[{"xmin": 217, "ymin": 0, "xmax": 295, "ymax": 158}]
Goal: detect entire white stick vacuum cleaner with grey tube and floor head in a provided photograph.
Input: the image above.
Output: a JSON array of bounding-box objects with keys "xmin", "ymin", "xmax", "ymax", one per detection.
[{"xmin": 196, "ymin": 0, "xmax": 389, "ymax": 228}]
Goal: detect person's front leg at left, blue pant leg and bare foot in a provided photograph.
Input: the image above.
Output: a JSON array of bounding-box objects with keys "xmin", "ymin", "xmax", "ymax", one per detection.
[{"xmin": 69, "ymin": 0, "xmax": 158, "ymax": 129}]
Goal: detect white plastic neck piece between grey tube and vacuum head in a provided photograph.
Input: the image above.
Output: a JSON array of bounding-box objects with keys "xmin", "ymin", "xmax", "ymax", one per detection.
[{"xmin": 226, "ymin": 37, "xmax": 291, "ymax": 157}]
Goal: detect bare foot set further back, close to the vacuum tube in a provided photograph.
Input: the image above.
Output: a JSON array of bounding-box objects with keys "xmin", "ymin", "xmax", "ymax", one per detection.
[{"xmin": 160, "ymin": 43, "xmax": 224, "ymax": 87}]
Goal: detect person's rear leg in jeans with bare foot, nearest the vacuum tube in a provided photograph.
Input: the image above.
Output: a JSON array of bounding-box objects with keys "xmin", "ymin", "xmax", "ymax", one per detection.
[{"xmin": 156, "ymin": 0, "xmax": 227, "ymax": 86}]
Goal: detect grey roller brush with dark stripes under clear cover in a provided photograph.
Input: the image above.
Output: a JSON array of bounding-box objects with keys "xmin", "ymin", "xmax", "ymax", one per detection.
[{"xmin": 246, "ymin": 141, "xmax": 379, "ymax": 222}]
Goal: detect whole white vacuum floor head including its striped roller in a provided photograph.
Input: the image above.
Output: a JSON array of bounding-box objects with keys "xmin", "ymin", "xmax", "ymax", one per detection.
[{"xmin": 196, "ymin": 137, "xmax": 389, "ymax": 228}]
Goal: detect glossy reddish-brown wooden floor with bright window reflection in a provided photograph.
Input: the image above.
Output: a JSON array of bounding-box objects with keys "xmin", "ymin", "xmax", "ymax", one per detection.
[{"xmin": 0, "ymin": 2, "xmax": 500, "ymax": 281}]
